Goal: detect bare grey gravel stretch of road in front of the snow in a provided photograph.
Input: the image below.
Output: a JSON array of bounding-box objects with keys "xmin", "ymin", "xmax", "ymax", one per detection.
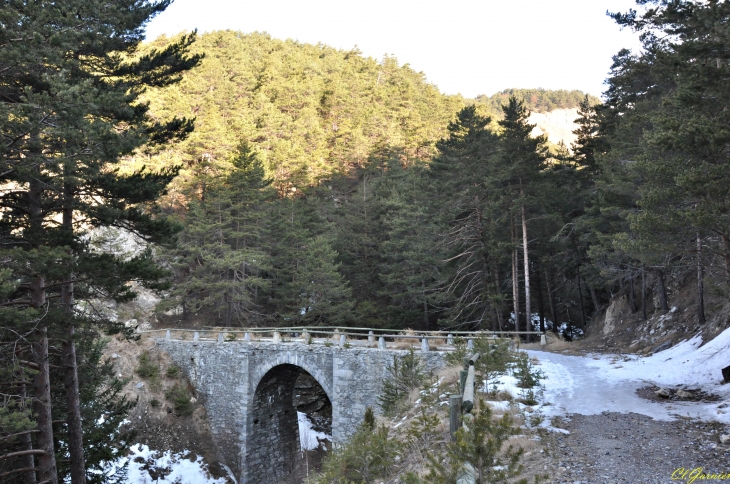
[{"xmin": 543, "ymin": 413, "xmax": 730, "ymax": 484}]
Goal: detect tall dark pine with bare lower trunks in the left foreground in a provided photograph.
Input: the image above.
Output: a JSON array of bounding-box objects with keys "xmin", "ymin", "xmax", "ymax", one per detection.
[{"xmin": 0, "ymin": 0, "xmax": 200, "ymax": 484}]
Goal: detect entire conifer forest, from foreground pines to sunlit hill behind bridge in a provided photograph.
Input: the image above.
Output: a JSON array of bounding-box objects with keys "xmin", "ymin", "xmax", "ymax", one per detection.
[{"xmin": 0, "ymin": 0, "xmax": 730, "ymax": 484}]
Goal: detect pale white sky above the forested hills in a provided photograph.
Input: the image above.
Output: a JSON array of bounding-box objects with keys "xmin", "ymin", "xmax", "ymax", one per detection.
[{"xmin": 147, "ymin": 0, "xmax": 639, "ymax": 98}]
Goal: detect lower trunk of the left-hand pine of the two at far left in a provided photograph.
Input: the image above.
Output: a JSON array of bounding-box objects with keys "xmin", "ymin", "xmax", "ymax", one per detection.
[{"xmin": 33, "ymin": 327, "xmax": 58, "ymax": 484}]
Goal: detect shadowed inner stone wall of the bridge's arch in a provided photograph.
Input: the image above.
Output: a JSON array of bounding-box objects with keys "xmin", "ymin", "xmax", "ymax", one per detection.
[{"xmin": 245, "ymin": 363, "xmax": 332, "ymax": 484}]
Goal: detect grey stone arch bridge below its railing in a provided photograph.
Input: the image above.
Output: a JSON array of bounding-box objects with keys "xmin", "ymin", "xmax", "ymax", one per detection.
[{"xmin": 157, "ymin": 338, "xmax": 445, "ymax": 484}]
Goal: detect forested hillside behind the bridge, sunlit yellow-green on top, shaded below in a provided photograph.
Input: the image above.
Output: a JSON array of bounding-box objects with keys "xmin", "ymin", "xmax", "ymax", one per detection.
[{"xmin": 132, "ymin": 31, "xmax": 584, "ymax": 328}]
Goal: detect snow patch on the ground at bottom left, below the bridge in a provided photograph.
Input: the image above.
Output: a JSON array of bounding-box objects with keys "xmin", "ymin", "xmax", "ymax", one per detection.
[{"xmin": 105, "ymin": 444, "xmax": 226, "ymax": 484}]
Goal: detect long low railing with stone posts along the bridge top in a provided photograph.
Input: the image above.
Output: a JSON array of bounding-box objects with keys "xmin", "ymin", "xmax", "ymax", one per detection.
[{"xmin": 141, "ymin": 326, "xmax": 546, "ymax": 351}]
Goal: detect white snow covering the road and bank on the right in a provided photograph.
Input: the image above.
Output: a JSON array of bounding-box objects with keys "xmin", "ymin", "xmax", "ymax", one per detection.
[{"xmin": 527, "ymin": 328, "xmax": 730, "ymax": 424}]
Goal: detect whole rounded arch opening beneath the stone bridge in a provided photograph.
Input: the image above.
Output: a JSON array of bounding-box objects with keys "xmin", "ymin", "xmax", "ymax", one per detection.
[{"xmin": 246, "ymin": 364, "xmax": 332, "ymax": 484}]
